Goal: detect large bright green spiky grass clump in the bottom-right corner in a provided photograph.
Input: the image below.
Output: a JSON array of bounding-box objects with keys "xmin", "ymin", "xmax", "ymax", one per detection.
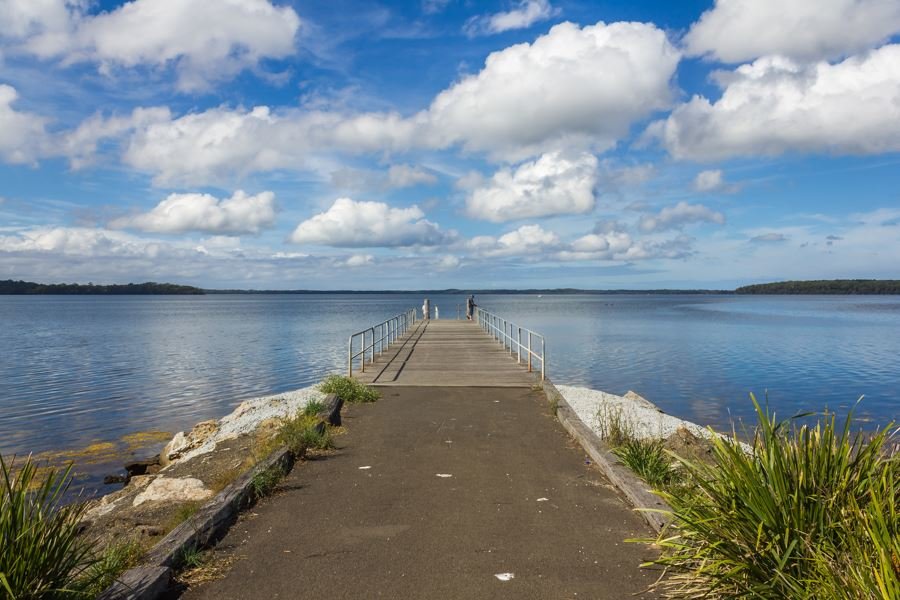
[{"xmin": 656, "ymin": 396, "xmax": 900, "ymax": 600}]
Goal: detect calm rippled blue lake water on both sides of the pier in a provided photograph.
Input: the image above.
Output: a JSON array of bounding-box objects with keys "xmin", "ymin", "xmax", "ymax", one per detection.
[{"xmin": 0, "ymin": 294, "xmax": 900, "ymax": 494}]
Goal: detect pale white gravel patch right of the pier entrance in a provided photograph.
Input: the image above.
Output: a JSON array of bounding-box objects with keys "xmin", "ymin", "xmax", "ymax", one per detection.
[{"xmin": 556, "ymin": 385, "xmax": 718, "ymax": 439}]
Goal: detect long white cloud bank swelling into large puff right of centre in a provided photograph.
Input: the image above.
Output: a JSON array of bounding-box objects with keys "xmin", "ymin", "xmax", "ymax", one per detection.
[{"xmin": 107, "ymin": 22, "xmax": 679, "ymax": 186}]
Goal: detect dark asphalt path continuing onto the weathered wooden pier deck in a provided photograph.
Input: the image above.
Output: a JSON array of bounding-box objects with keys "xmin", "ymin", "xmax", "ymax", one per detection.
[{"xmin": 183, "ymin": 321, "xmax": 658, "ymax": 600}]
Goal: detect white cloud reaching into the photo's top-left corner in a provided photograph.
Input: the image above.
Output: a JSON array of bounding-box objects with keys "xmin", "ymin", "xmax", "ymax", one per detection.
[{"xmin": 0, "ymin": 0, "xmax": 300, "ymax": 91}]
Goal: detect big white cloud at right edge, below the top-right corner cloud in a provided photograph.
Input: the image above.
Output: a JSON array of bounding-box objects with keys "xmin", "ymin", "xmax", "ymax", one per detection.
[{"xmin": 648, "ymin": 44, "xmax": 900, "ymax": 161}]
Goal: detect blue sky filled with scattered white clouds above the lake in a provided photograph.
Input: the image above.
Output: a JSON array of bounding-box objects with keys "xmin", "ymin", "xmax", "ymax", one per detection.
[{"xmin": 0, "ymin": 0, "xmax": 900, "ymax": 289}]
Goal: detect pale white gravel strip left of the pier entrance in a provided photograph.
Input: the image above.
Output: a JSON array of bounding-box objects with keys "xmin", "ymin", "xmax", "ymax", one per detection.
[{"xmin": 179, "ymin": 386, "xmax": 325, "ymax": 461}]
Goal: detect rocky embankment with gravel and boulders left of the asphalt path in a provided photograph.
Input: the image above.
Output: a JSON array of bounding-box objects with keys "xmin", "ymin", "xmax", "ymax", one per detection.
[{"xmin": 78, "ymin": 387, "xmax": 325, "ymax": 548}]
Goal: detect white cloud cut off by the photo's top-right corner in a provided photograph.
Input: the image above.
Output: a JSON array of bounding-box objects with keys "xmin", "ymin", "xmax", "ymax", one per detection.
[{"xmin": 684, "ymin": 0, "xmax": 900, "ymax": 63}]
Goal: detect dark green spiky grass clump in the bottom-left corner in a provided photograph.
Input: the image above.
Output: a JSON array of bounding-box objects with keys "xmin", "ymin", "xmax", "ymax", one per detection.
[{"xmin": 0, "ymin": 456, "xmax": 98, "ymax": 600}]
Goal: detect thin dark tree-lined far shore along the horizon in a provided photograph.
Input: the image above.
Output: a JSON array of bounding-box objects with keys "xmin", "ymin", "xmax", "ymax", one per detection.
[{"xmin": 0, "ymin": 279, "xmax": 900, "ymax": 296}]
